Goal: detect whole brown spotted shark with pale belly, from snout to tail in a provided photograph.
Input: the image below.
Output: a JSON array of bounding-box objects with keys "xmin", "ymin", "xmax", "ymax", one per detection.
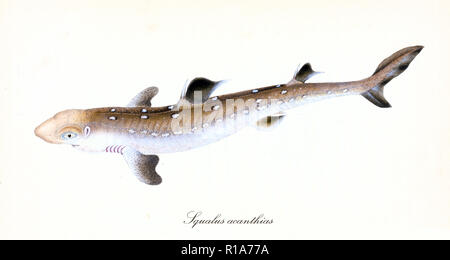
[{"xmin": 34, "ymin": 46, "xmax": 423, "ymax": 185}]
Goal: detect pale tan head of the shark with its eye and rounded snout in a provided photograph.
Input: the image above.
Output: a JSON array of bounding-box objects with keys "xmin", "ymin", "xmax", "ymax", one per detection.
[{"xmin": 34, "ymin": 109, "xmax": 90, "ymax": 146}]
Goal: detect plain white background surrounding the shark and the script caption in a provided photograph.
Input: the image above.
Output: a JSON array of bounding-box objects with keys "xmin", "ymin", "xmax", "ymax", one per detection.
[{"xmin": 0, "ymin": 0, "xmax": 450, "ymax": 239}]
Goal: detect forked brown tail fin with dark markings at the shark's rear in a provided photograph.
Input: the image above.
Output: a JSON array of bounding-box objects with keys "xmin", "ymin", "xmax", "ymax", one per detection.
[{"xmin": 362, "ymin": 46, "xmax": 423, "ymax": 107}]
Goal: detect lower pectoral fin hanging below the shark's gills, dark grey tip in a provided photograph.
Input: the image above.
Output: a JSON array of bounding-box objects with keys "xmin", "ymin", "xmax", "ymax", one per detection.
[{"xmin": 123, "ymin": 147, "xmax": 162, "ymax": 185}]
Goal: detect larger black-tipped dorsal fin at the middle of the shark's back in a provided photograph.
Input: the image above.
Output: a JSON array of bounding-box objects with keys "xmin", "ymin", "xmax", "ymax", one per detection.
[{"xmin": 181, "ymin": 78, "xmax": 222, "ymax": 104}]
